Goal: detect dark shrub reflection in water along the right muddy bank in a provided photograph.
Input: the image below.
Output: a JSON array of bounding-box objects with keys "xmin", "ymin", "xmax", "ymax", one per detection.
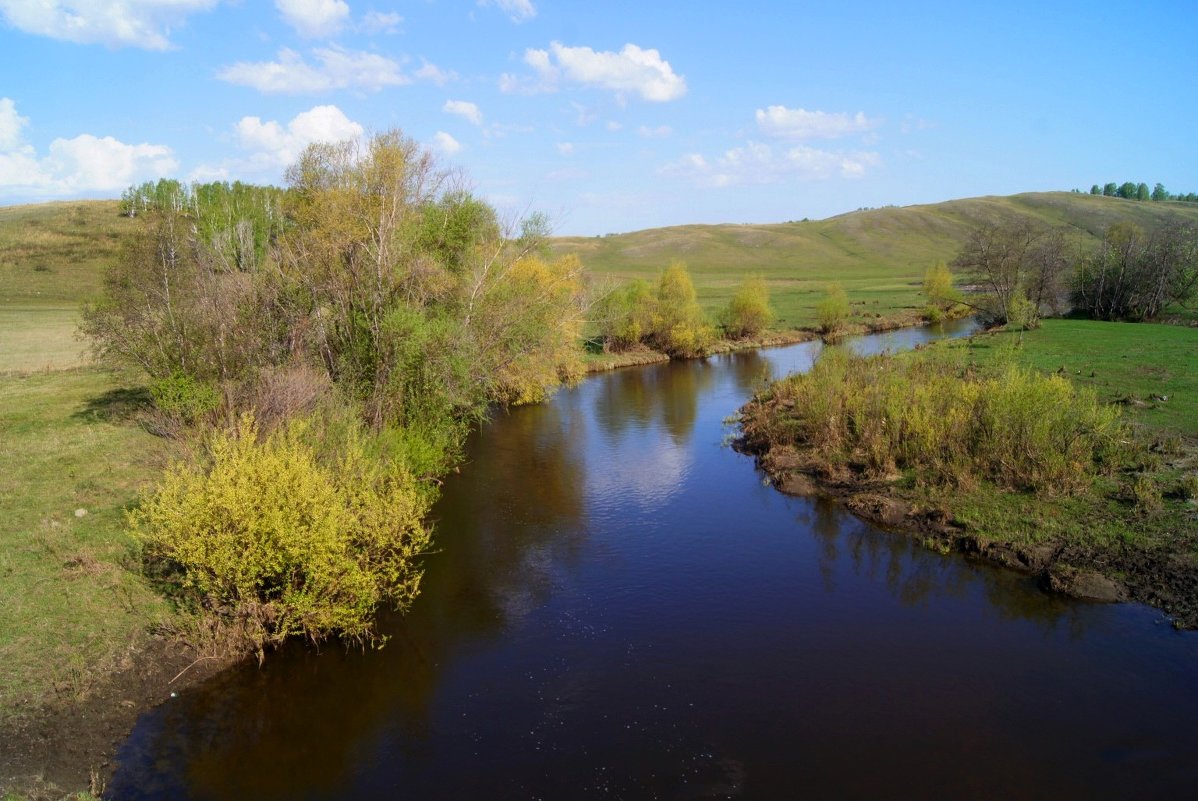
[{"xmin": 798, "ymin": 497, "xmax": 1095, "ymax": 639}]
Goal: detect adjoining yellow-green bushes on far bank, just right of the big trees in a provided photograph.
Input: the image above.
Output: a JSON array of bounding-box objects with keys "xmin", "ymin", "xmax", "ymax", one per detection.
[{"xmin": 595, "ymin": 261, "xmax": 774, "ymax": 357}]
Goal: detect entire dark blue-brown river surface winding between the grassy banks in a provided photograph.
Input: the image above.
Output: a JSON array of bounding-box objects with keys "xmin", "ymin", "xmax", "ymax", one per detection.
[{"xmin": 109, "ymin": 320, "xmax": 1198, "ymax": 800}]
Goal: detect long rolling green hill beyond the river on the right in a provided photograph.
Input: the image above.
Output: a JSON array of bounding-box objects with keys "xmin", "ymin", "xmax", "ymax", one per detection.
[{"xmin": 553, "ymin": 192, "xmax": 1198, "ymax": 328}]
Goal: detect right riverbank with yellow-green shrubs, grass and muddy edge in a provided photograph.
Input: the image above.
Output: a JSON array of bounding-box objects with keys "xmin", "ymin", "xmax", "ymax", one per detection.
[{"xmin": 745, "ymin": 320, "xmax": 1198, "ymax": 627}]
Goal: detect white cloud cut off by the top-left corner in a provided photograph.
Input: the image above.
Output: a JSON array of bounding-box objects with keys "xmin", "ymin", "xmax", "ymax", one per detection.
[{"xmin": 0, "ymin": 0, "xmax": 218, "ymax": 50}]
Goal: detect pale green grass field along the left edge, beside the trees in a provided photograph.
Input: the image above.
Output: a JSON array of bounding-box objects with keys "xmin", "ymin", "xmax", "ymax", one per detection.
[{"xmin": 0, "ymin": 201, "xmax": 167, "ymax": 720}]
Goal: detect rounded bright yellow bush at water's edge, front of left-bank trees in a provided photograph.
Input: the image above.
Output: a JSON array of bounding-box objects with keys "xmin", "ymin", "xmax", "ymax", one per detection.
[{"xmin": 129, "ymin": 415, "xmax": 432, "ymax": 659}]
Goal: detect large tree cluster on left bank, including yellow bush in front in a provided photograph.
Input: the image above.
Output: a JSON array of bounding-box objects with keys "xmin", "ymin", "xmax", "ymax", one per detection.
[{"xmin": 83, "ymin": 132, "xmax": 585, "ymax": 654}]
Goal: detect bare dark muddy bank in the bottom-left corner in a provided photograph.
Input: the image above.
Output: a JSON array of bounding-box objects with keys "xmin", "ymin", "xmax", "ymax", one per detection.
[{"xmin": 0, "ymin": 635, "xmax": 235, "ymax": 800}]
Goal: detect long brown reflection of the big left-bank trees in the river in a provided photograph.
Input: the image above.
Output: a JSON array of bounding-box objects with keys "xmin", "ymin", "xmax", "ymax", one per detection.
[{"xmin": 114, "ymin": 399, "xmax": 585, "ymax": 799}]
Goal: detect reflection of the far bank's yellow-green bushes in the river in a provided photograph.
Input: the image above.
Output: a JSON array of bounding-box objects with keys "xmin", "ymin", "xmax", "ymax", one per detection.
[{"xmin": 594, "ymin": 359, "xmax": 714, "ymax": 445}]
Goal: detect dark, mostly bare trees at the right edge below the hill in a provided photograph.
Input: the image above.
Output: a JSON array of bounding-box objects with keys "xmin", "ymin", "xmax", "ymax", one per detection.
[{"xmin": 924, "ymin": 215, "xmax": 1198, "ymax": 328}]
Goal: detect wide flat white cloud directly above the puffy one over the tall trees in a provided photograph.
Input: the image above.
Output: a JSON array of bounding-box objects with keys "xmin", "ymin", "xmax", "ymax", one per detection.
[{"xmin": 217, "ymin": 45, "xmax": 412, "ymax": 95}]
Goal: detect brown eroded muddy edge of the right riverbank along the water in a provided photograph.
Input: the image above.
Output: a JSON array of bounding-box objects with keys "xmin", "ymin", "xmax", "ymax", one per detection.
[{"xmin": 736, "ymin": 438, "xmax": 1198, "ymax": 629}]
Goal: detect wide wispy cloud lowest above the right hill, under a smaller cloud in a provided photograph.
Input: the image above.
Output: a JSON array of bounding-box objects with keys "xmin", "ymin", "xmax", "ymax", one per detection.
[{"xmin": 660, "ymin": 141, "xmax": 881, "ymax": 187}]
